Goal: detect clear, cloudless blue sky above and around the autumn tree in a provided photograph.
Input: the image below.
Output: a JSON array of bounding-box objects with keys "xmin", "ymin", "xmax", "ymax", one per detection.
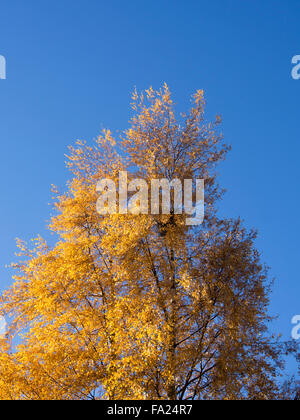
[{"xmin": 0, "ymin": 0, "xmax": 300, "ymax": 370}]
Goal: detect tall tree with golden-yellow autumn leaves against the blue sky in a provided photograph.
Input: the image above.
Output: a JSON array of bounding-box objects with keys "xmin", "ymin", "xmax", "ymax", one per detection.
[{"xmin": 0, "ymin": 86, "xmax": 292, "ymax": 400}]
